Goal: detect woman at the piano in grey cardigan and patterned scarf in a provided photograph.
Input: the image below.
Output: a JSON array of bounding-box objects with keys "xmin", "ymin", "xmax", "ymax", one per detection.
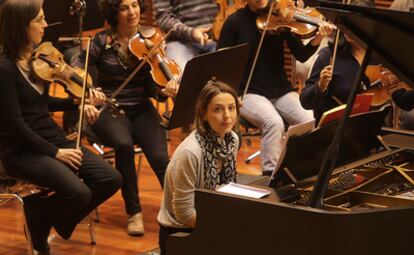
[{"xmin": 158, "ymin": 81, "xmax": 239, "ymax": 254}]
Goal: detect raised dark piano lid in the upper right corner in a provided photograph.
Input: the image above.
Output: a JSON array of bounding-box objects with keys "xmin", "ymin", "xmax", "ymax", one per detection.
[{"xmin": 317, "ymin": 1, "xmax": 414, "ymax": 87}]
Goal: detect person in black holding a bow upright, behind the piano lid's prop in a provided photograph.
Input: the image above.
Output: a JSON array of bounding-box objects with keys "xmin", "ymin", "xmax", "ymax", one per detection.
[{"xmin": 300, "ymin": 0, "xmax": 374, "ymax": 121}]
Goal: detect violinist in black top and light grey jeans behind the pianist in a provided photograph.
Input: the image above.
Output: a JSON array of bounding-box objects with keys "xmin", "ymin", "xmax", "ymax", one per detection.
[{"xmin": 218, "ymin": 0, "xmax": 332, "ymax": 175}]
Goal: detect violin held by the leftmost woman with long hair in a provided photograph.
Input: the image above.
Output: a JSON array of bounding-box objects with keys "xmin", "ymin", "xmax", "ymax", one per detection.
[{"xmin": 29, "ymin": 42, "xmax": 118, "ymax": 112}]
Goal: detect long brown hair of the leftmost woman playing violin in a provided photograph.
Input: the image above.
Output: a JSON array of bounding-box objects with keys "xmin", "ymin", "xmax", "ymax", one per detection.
[{"xmin": 0, "ymin": 0, "xmax": 43, "ymax": 61}]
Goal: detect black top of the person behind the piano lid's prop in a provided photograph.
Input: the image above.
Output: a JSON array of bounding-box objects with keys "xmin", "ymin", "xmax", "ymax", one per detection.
[{"xmin": 300, "ymin": 47, "xmax": 369, "ymax": 121}]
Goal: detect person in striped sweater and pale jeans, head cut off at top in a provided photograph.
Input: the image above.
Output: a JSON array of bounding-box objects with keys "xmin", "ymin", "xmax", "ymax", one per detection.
[{"xmin": 154, "ymin": 0, "xmax": 218, "ymax": 71}]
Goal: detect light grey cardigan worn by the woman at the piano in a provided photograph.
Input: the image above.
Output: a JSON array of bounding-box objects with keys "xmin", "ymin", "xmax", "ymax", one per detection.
[{"xmin": 158, "ymin": 131, "xmax": 239, "ymax": 228}]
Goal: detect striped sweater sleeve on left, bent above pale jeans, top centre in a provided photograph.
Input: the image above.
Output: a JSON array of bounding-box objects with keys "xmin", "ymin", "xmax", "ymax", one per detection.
[{"xmin": 154, "ymin": 0, "xmax": 194, "ymax": 42}]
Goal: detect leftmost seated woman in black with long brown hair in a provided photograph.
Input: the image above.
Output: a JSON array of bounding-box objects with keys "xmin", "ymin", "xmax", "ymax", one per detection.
[{"xmin": 0, "ymin": 0, "xmax": 122, "ymax": 254}]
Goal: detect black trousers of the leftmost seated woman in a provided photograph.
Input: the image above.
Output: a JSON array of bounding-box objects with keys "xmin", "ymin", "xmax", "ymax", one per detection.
[{"xmin": 3, "ymin": 146, "xmax": 122, "ymax": 239}]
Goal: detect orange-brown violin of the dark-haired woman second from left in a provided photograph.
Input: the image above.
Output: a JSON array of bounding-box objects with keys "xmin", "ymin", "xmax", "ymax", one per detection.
[{"xmin": 128, "ymin": 27, "xmax": 181, "ymax": 87}]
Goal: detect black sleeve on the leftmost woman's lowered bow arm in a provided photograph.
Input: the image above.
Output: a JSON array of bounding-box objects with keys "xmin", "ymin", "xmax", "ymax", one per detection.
[{"xmin": 0, "ymin": 64, "xmax": 59, "ymax": 157}]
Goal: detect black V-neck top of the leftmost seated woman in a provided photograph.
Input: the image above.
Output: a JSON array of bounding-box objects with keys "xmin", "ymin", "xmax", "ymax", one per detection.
[{"xmin": 0, "ymin": 56, "xmax": 74, "ymax": 160}]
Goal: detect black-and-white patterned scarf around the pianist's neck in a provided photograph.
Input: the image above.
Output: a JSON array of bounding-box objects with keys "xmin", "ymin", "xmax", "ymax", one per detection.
[{"xmin": 195, "ymin": 129, "xmax": 237, "ymax": 190}]
